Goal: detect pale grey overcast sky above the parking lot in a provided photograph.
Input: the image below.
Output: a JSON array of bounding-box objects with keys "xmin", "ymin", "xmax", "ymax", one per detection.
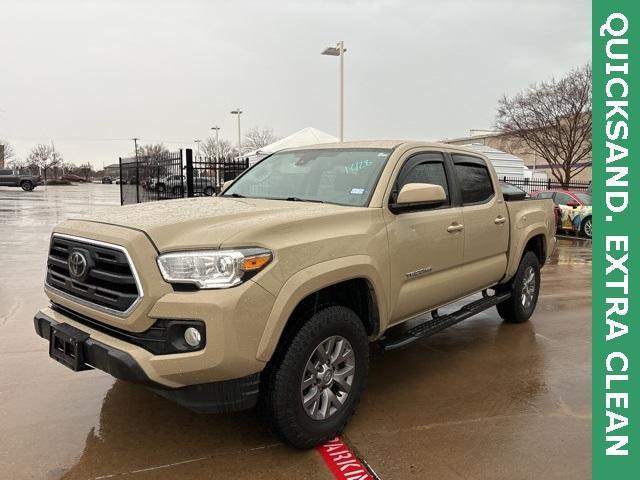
[{"xmin": 0, "ymin": 0, "xmax": 591, "ymax": 167}]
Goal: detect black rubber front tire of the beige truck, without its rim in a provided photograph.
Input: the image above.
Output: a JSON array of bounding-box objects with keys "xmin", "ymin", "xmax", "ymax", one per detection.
[{"xmin": 260, "ymin": 306, "xmax": 369, "ymax": 449}]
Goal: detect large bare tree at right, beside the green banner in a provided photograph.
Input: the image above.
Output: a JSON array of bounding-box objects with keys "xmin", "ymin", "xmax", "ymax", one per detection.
[{"xmin": 496, "ymin": 64, "xmax": 592, "ymax": 187}]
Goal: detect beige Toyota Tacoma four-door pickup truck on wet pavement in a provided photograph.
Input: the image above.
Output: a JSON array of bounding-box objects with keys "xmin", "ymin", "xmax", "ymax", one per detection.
[{"xmin": 35, "ymin": 141, "xmax": 555, "ymax": 448}]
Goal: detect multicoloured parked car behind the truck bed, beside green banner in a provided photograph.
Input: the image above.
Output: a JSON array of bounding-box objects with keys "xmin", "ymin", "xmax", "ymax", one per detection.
[{"xmin": 533, "ymin": 189, "xmax": 592, "ymax": 238}]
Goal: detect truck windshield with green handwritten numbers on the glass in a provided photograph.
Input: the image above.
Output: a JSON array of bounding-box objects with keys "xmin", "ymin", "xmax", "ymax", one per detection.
[{"xmin": 223, "ymin": 148, "xmax": 391, "ymax": 207}]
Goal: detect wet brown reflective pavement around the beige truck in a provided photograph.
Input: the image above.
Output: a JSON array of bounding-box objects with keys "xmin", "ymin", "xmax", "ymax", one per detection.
[{"xmin": 0, "ymin": 185, "xmax": 591, "ymax": 480}]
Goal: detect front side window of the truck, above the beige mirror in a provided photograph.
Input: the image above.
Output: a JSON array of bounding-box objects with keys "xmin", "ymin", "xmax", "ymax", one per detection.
[{"xmin": 389, "ymin": 153, "xmax": 451, "ymax": 206}]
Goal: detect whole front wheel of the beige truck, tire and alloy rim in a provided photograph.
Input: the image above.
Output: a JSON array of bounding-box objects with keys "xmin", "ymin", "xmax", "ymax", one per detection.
[{"xmin": 261, "ymin": 306, "xmax": 369, "ymax": 448}]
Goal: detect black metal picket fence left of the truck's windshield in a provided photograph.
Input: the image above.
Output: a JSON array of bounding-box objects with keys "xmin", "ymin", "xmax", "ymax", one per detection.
[{"xmin": 120, "ymin": 149, "xmax": 249, "ymax": 205}]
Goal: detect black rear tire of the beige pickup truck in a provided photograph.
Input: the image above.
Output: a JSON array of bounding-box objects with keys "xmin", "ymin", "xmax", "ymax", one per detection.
[{"xmin": 496, "ymin": 252, "xmax": 540, "ymax": 323}]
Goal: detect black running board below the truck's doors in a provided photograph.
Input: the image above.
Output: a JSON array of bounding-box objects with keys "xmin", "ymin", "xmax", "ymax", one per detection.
[{"xmin": 378, "ymin": 292, "xmax": 511, "ymax": 352}]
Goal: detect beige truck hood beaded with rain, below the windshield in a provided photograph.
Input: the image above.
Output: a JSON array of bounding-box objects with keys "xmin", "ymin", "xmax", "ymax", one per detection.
[{"xmin": 70, "ymin": 197, "xmax": 362, "ymax": 253}]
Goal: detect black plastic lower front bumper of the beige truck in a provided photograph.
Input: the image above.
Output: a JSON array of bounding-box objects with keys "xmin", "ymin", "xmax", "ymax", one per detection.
[{"xmin": 33, "ymin": 312, "xmax": 260, "ymax": 413}]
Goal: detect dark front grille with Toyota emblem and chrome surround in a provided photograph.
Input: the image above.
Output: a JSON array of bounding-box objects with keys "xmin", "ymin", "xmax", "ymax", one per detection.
[{"xmin": 46, "ymin": 234, "xmax": 142, "ymax": 314}]
